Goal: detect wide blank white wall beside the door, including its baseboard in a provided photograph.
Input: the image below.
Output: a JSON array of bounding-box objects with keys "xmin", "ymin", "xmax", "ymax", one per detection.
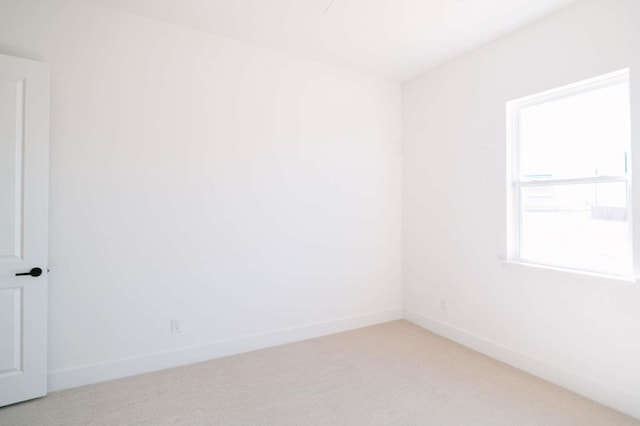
[{"xmin": 0, "ymin": 0, "xmax": 402, "ymax": 389}]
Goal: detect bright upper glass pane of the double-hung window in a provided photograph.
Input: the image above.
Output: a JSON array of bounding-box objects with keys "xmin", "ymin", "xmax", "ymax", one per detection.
[{"xmin": 518, "ymin": 81, "xmax": 631, "ymax": 180}]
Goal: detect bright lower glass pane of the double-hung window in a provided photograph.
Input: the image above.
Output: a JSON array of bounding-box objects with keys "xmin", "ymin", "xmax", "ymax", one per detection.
[{"xmin": 520, "ymin": 182, "xmax": 632, "ymax": 275}]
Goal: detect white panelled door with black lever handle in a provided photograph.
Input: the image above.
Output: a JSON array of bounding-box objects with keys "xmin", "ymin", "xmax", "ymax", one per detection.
[{"xmin": 0, "ymin": 55, "xmax": 49, "ymax": 406}]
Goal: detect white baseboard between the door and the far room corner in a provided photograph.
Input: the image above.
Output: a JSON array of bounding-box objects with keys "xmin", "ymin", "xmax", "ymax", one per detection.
[{"xmin": 48, "ymin": 308, "xmax": 402, "ymax": 392}]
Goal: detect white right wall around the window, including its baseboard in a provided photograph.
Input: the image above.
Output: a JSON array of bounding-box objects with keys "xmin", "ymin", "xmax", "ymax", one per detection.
[{"xmin": 403, "ymin": 0, "xmax": 640, "ymax": 417}]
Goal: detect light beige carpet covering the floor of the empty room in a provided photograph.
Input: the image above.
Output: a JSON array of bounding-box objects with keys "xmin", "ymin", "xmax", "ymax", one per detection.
[{"xmin": 0, "ymin": 321, "xmax": 640, "ymax": 426}]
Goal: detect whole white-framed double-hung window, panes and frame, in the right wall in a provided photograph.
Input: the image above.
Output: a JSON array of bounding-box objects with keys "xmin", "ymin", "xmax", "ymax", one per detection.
[{"xmin": 507, "ymin": 70, "xmax": 633, "ymax": 277}]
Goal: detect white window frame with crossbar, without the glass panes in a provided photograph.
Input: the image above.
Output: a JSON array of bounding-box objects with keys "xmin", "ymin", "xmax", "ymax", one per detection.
[{"xmin": 506, "ymin": 68, "xmax": 639, "ymax": 281}]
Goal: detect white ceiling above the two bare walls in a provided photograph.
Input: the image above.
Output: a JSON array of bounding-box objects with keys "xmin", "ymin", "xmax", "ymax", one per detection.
[{"xmin": 90, "ymin": 0, "xmax": 576, "ymax": 80}]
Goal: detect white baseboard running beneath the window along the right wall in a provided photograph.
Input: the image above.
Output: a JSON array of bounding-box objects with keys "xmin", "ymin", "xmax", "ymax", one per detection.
[{"xmin": 404, "ymin": 309, "xmax": 640, "ymax": 418}]
